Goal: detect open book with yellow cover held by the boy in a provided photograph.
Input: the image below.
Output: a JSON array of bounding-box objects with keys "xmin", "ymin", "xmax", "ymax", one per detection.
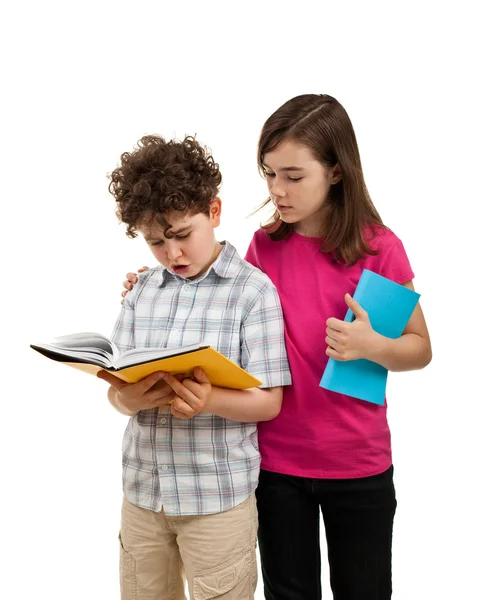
[{"xmin": 31, "ymin": 332, "xmax": 262, "ymax": 390}]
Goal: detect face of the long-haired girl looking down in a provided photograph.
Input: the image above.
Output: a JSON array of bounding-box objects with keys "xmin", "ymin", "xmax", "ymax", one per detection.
[{"xmin": 263, "ymin": 140, "xmax": 341, "ymax": 237}]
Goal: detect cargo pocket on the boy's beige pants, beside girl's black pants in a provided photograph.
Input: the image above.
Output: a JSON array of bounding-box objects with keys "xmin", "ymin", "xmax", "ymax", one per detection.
[{"xmin": 193, "ymin": 548, "xmax": 257, "ymax": 600}]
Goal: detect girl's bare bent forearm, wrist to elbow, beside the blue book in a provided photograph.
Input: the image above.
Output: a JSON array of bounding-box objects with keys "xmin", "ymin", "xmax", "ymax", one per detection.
[{"xmin": 365, "ymin": 333, "xmax": 432, "ymax": 371}]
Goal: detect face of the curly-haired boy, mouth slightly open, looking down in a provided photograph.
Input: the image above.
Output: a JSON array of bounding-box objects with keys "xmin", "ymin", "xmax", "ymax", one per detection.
[{"xmin": 138, "ymin": 198, "xmax": 222, "ymax": 279}]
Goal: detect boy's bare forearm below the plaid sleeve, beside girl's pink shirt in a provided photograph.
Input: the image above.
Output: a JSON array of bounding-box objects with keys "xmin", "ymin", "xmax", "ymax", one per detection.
[{"xmin": 205, "ymin": 387, "xmax": 282, "ymax": 423}]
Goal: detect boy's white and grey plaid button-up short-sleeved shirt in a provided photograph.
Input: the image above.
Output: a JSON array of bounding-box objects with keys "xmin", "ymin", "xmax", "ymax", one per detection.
[{"xmin": 113, "ymin": 242, "xmax": 291, "ymax": 516}]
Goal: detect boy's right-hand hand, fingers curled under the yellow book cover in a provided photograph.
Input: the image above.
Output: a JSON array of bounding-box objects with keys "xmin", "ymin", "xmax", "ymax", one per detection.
[{"xmin": 165, "ymin": 367, "xmax": 212, "ymax": 419}]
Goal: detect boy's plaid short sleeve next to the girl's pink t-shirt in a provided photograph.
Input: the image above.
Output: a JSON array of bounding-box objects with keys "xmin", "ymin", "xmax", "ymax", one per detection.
[{"xmin": 240, "ymin": 284, "xmax": 291, "ymax": 388}]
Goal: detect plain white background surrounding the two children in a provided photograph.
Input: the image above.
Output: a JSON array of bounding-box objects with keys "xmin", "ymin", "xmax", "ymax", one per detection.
[{"xmin": 0, "ymin": 0, "xmax": 493, "ymax": 600}]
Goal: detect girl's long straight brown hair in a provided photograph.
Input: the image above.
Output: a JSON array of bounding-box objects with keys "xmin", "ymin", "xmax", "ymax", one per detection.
[{"xmin": 257, "ymin": 94, "xmax": 384, "ymax": 265}]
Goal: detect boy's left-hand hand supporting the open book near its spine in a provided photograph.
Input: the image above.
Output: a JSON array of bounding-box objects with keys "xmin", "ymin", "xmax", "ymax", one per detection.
[{"xmin": 97, "ymin": 371, "xmax": 180, "ymax": 414}]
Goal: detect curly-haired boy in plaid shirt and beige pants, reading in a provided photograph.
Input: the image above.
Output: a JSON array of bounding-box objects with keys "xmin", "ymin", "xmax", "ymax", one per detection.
[{"xmin": 99, "ymin": 136, "xmax": 291, "ymax": 600}]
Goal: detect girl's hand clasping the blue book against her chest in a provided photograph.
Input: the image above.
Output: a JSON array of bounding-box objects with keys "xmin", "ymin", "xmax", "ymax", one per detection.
[{"xmin": 325, "ymin": 294, "xmax": 380, "ymax": 361}]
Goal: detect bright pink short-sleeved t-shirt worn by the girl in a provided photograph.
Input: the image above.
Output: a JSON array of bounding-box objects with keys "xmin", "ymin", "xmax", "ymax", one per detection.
[{"xmin": 245, "ymin": 228, "xmax": 414, "ymax": 479}]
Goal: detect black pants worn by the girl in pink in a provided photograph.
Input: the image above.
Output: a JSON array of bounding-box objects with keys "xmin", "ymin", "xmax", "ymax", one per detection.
[{"xmin": 257, "ymin": 467, "xmax": 396, "ymax": 600}]
